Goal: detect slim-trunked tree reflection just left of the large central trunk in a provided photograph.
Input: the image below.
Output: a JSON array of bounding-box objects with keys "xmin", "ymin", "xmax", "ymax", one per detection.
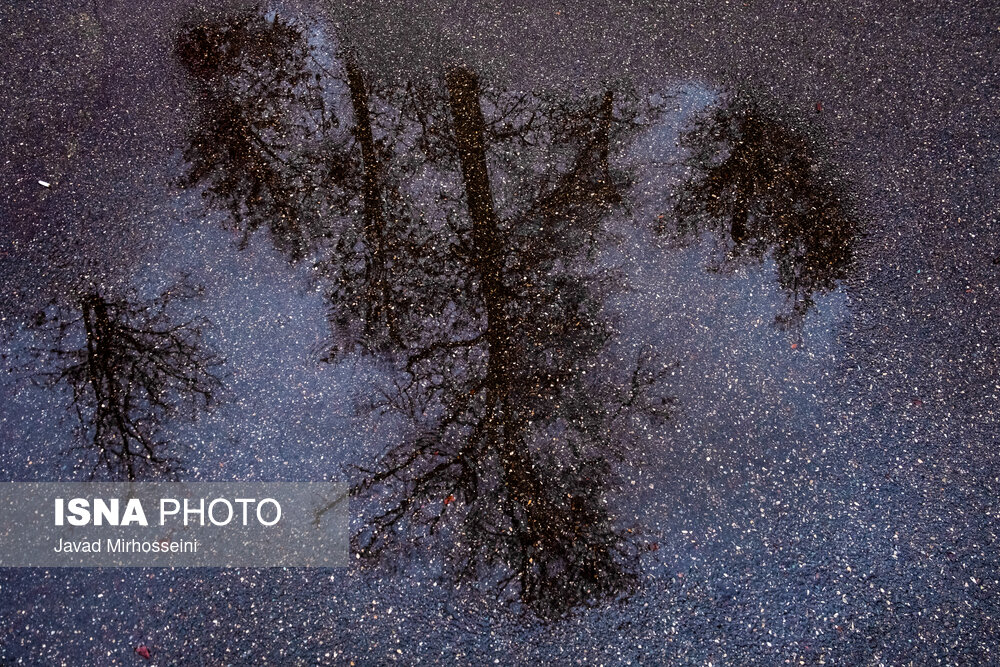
[{"xmin": 320, "ymin": 53, "xmax": 432, "ymax": 359}]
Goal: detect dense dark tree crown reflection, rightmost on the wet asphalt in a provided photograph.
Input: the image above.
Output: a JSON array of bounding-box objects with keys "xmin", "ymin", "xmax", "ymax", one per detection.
[{"xmin": 660, "ymin": 95, "xmax": 858, "ymax": 327}]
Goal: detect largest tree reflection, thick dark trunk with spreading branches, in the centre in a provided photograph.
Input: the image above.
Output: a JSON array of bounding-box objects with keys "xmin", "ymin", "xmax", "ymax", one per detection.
[{"xmin": 356, "ymin": 68, "xmax": 670, "ymax": 616}]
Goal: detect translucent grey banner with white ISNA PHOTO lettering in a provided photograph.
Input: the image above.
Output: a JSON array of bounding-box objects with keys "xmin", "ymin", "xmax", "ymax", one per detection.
[{"xmin": 0, "ymin": 482, "xmax": 349, "ymax": 567}]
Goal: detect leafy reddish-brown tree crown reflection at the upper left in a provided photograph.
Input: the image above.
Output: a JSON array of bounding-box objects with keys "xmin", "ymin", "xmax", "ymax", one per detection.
[{"xmin": 175, "ymin": 12, "xmax": 358, "ymax": 260}]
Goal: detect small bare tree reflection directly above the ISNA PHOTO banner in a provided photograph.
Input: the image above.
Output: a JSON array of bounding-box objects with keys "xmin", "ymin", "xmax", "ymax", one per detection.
[{"xmin": 28, "ymin": 287, "xmax": 221, "ymax": 480}]
